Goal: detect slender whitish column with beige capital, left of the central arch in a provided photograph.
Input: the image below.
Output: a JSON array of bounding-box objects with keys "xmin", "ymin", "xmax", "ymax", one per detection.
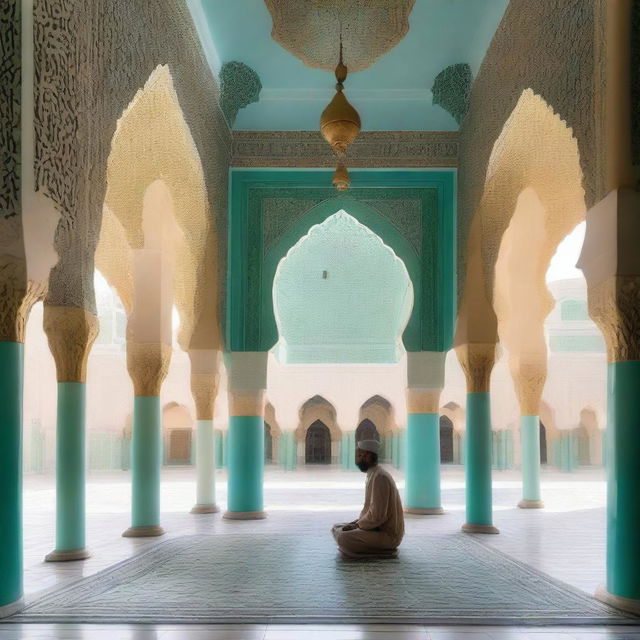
[{"xmin": 189, "ymin": 350, "xmax": 220, "ymax": 513}]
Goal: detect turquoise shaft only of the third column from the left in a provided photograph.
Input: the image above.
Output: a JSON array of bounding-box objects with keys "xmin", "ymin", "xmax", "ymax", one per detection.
[{"xmin": 131, "ymin": 396, "xmax": 162, "ymax": 527}]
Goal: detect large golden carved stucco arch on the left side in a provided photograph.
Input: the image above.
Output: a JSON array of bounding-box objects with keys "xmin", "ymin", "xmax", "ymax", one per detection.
[{"xmin": 98, "ymin": 65, "xmax": 221, "ymax": 349}]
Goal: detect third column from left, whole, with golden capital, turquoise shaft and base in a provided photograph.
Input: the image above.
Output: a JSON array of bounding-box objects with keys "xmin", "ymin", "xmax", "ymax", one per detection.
[{"xmin": 122, "ymin": 342, "xmax": 171, "ymax": 538}]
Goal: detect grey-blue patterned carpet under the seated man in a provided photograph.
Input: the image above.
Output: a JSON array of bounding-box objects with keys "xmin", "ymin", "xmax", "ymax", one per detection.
[{"xmin": 11, "ymin": 531, "xmax": 631, "ymax": 625}]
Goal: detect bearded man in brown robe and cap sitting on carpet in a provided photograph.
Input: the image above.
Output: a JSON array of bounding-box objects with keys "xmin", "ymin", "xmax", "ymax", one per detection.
[{"xmin": 331, "ymin": 440, "xmax": 404, "ymax": 558}]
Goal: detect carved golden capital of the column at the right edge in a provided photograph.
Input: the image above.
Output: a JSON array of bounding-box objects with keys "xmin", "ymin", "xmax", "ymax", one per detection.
[{"xmin": 588, "ymin": 275, "xmax": 640, "ymax": 362}]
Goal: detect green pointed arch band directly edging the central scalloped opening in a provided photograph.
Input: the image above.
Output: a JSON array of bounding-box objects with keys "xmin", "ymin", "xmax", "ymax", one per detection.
[{"xmin": 260, "ymin": 196, "xmax": 422, "ymax": 351}]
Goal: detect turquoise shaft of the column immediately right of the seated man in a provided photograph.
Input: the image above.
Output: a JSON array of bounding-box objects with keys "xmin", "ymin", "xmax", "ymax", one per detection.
[{"xmin": 405, "ymin": 413, "xmax": 442, "ymax": 509}]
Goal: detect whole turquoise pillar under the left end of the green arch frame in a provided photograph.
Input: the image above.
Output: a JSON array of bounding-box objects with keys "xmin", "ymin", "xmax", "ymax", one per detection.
[{"xmin": 224, "ymin": 351, "xmax": 267, "ymax": 520}]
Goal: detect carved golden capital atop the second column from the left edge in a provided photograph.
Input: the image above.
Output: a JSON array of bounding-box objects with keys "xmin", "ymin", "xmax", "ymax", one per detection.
[{"xmin": 44, "ymin": 305, "xmax": 99, "ymax": 382}]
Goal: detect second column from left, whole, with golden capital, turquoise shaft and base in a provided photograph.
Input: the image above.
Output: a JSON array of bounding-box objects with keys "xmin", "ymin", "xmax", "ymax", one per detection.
[{"xmin": 44, "ymin": 305, "xmax": 99, "ymax": 562}]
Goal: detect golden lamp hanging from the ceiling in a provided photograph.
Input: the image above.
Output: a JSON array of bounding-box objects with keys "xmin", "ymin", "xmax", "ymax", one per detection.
[{"xmin": 320, "ymin": 35, "xmax": 361, "ymax": 191}]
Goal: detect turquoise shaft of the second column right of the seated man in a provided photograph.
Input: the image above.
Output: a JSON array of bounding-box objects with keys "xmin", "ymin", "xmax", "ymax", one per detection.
[{"xmin": 465, "ymin": 392, "xmax": 493, "ymax": 525}]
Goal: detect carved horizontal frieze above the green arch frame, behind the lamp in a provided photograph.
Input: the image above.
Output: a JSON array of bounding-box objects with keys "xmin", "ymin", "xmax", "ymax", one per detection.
[{"xmin": 231, "ymin": 131, "xmax": 458, "ymax": 168}]
